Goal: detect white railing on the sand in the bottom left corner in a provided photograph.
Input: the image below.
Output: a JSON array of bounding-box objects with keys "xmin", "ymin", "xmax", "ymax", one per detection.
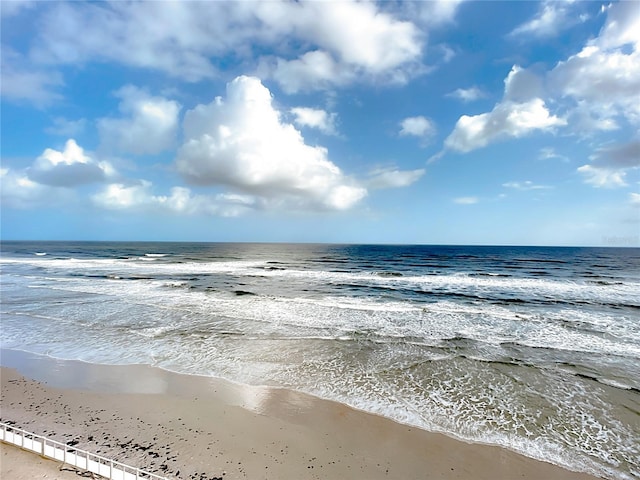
[{"xmin": 0, "ymin": 422, "xmax": 168, "ymax": 480}]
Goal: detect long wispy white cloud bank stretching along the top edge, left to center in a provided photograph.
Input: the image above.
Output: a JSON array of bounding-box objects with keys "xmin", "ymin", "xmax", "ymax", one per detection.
[{"xmin": 32, "ymin": 0, "xmax": 423, "ymax": 91}]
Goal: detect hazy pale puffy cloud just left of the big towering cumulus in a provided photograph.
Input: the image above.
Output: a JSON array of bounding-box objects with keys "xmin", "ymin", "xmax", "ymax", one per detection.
[{"xmin": 97, "ymin": 85, "xmax": 180, "ymax": 155}]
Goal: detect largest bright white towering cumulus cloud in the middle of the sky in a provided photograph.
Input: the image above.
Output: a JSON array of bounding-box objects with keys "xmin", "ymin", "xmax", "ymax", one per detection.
[{"xmin": 176, "ymin": 76, "xmax": 367, "ymax": 210}]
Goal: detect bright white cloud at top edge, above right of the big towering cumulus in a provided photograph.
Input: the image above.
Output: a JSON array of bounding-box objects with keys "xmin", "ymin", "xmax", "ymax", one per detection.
[{"xmin": 255, "ymin": 1, "xmax": 423, "ymax": 93}]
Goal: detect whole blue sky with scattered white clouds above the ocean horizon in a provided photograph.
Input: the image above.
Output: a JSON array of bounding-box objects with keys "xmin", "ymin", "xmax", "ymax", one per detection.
[{"xmin": 0, "ymin": 0, "xmax": 640, "ymax": 247}]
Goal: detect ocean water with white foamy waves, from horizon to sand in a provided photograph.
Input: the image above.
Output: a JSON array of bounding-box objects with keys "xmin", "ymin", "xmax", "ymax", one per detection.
[{"xmin": 0, "ymin": 242, "xmax": 640, "ymax": 479}]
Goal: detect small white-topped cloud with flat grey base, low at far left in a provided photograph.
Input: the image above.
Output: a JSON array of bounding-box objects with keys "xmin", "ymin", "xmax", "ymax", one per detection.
[{"xmin": 27, "ymin": 139, "xmax": 116, "ymax": 187}]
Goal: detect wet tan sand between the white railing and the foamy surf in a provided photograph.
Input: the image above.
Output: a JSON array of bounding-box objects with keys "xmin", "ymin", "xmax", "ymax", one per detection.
[{"xmin": 0, "ymin": 350, "xmax": 594, "ymax": 480}]
